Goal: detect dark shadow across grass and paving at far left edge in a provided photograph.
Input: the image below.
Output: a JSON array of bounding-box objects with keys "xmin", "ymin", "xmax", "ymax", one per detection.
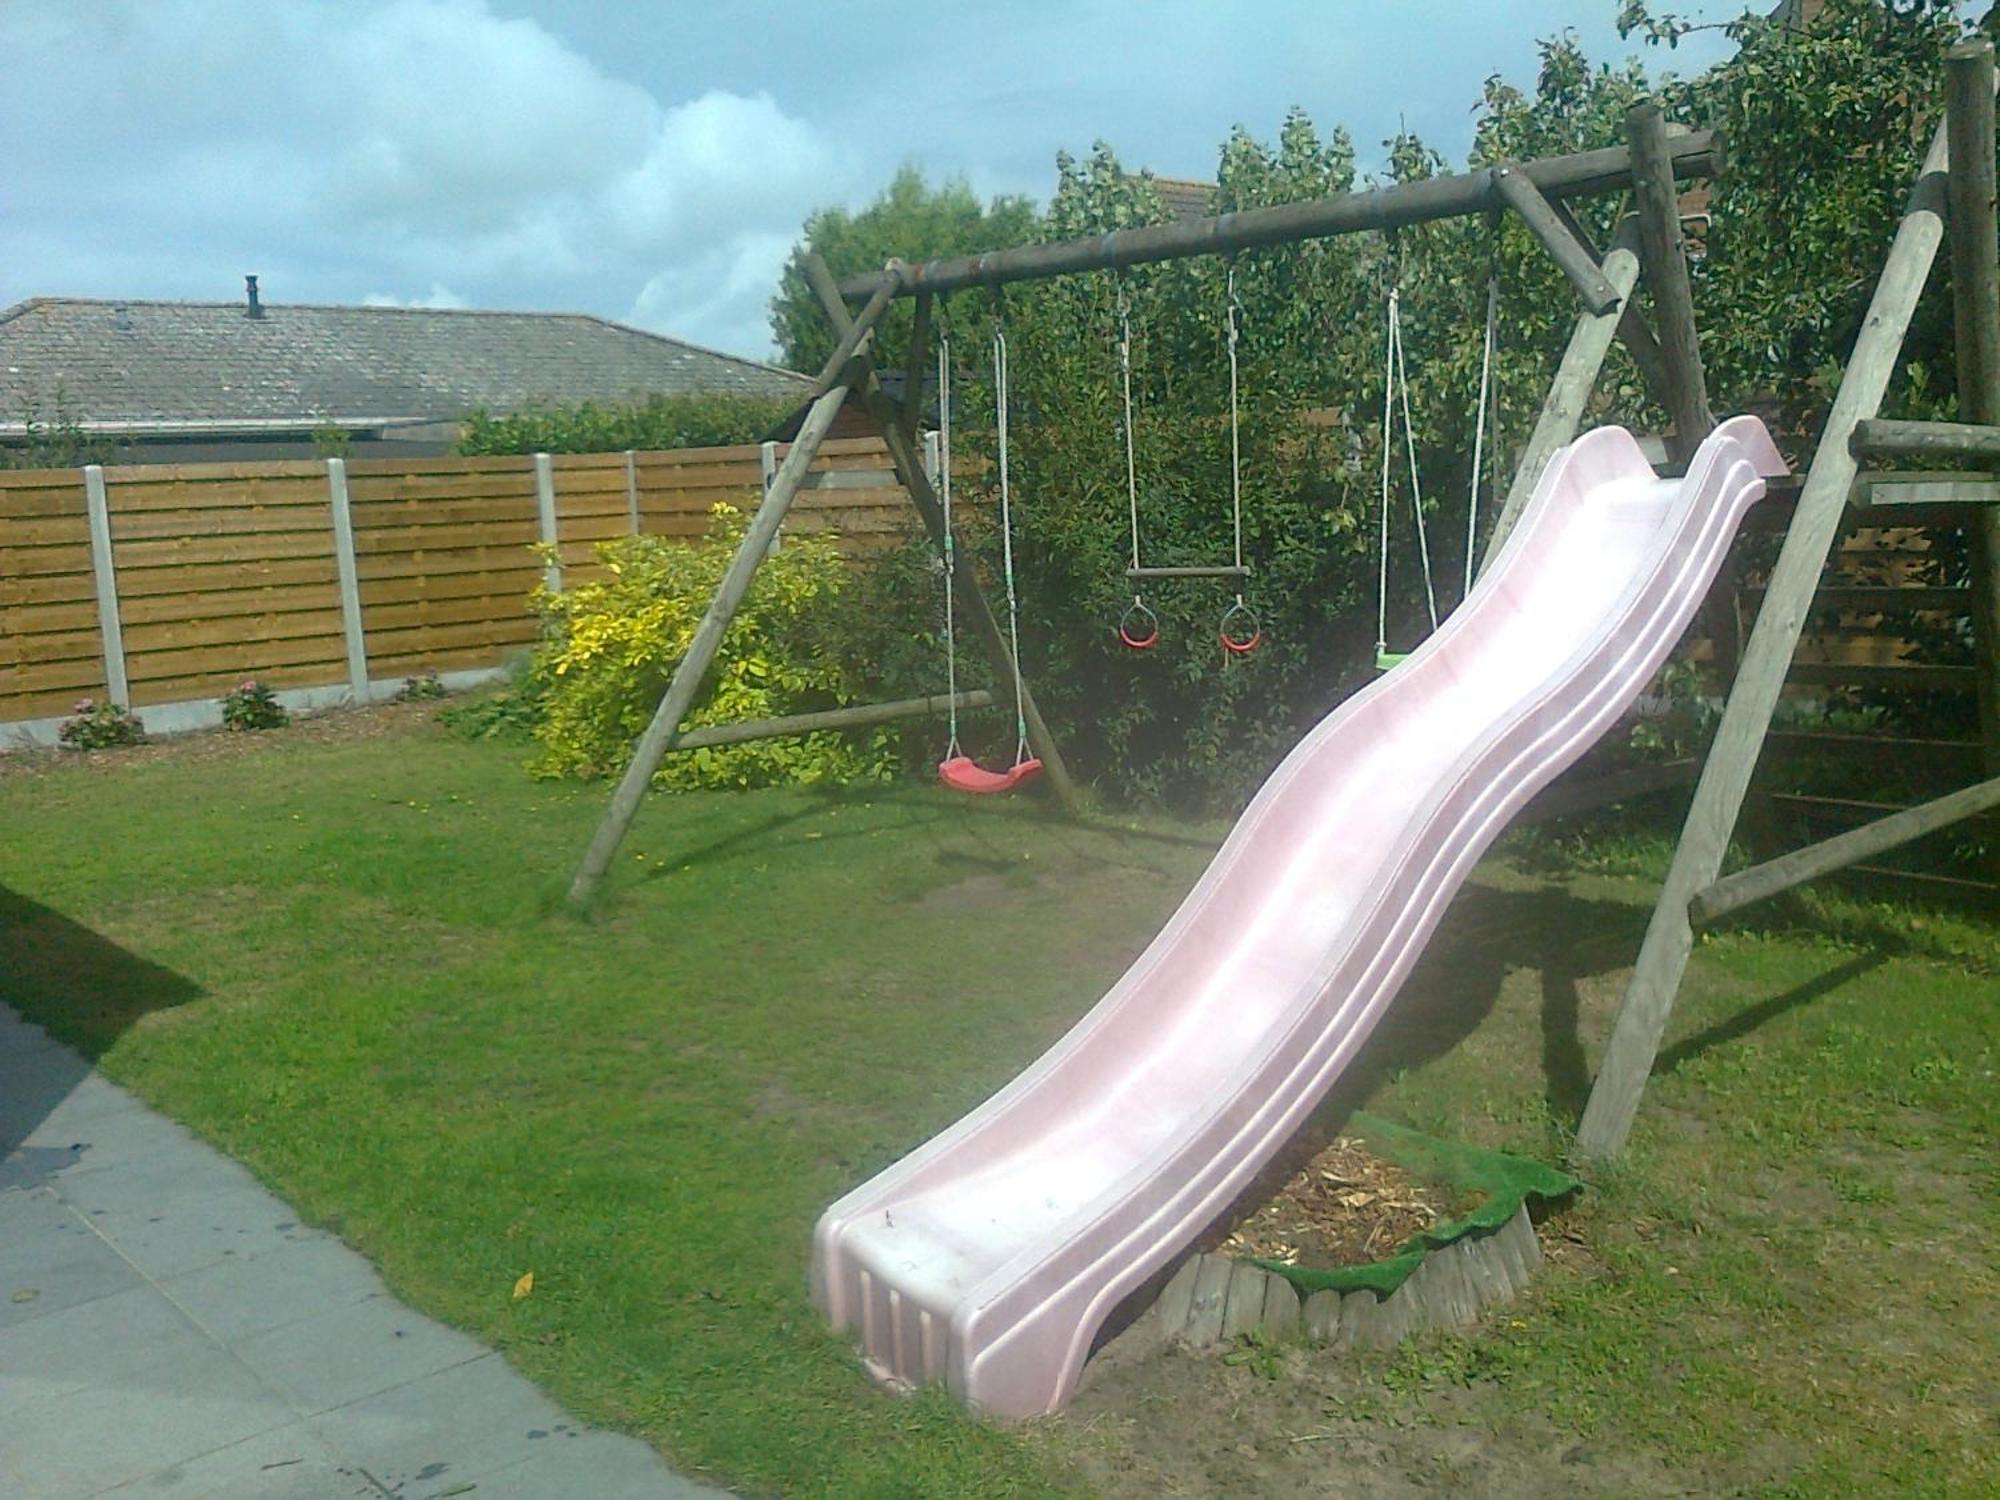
[{"xmin": 0, "ymin": 886, "xmax": 204, "ymax": 1188}]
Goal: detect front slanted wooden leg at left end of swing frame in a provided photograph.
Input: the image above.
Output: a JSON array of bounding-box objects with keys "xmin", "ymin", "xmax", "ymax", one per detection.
[{"xmin": 570, "ymin": 346, "xmax": 866, "ymax": 906}]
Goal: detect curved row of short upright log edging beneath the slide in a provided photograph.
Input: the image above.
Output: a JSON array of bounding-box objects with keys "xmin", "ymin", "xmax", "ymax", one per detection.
[{"xmin": 1150, "ymin": 1204, "xmax": 1542, "ymax": 1348}]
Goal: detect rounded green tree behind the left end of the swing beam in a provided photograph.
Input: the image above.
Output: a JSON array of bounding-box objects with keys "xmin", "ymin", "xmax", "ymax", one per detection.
[{"xmin": 770, "ymin": 166, "xmax": 1036, "ymax": 374}]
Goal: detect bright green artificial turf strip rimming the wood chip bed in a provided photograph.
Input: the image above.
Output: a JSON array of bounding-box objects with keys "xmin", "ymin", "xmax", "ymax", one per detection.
[{"xmin": 1250, "ymin": 1114, "xmax": 1584, "ymax": 1296}]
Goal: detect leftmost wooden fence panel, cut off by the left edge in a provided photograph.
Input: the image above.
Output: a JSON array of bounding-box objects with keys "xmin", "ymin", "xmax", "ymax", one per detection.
[{"xmin": 0, "ymin": 468, "xmax": 110, "ymax": 722}]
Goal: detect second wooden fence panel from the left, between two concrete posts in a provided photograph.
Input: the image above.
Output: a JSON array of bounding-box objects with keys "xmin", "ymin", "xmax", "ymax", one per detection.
[{"xmin": 104, "ymin": 462, "xmax": 346, "ymax": 706}]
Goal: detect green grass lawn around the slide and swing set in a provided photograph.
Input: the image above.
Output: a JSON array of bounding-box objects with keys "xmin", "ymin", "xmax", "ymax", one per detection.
[{"xmin": 0, "ymin": 710, "xmax": 2000, "ymax": 1496}]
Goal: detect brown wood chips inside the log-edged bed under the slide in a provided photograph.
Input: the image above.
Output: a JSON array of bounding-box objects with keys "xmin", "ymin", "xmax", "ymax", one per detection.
[{"xmin": 1220, "ymin": 1136, "xmax": 1472, "ymax": 1270}]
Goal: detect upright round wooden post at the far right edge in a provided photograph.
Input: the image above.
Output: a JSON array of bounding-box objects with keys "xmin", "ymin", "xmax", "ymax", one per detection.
[{"xmin": 1944, "ymin": 36, "xmax": 2000, "ymax": 776}]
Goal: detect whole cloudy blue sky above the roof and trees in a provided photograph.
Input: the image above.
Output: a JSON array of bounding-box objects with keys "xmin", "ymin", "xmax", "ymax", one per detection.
[{"xmin": 0, "ymin": 0, "xmax": 1740, "ymax": 368}]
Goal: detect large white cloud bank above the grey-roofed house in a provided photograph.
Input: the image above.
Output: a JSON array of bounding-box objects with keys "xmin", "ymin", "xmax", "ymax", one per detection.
[{"xmin": 0, "ymin": 0, "xmax": 858, "ymax": 352}]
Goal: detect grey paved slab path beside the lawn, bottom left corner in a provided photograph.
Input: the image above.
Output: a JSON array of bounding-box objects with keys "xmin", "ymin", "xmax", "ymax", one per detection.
[{"xmin": 0, "ymin": 1006, "xmax": 736, "ymax": 1500}]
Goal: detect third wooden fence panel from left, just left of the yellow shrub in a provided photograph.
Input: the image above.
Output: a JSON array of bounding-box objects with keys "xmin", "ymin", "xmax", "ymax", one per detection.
[{"xmin": 348, "ymin": 458, "xmax": 542, "ymax": 678}]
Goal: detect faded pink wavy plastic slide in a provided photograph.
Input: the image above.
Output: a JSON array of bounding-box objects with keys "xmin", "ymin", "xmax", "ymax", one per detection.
[{"xmin": 812, "ymin": 416, "xmax": 1784, "ymax": 1416}]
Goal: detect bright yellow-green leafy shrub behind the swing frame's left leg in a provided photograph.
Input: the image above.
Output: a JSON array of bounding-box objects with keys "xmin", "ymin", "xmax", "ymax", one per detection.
[{"xmin": 532, "ymin": 504, "xmax": 894, "ymax": 790}]
